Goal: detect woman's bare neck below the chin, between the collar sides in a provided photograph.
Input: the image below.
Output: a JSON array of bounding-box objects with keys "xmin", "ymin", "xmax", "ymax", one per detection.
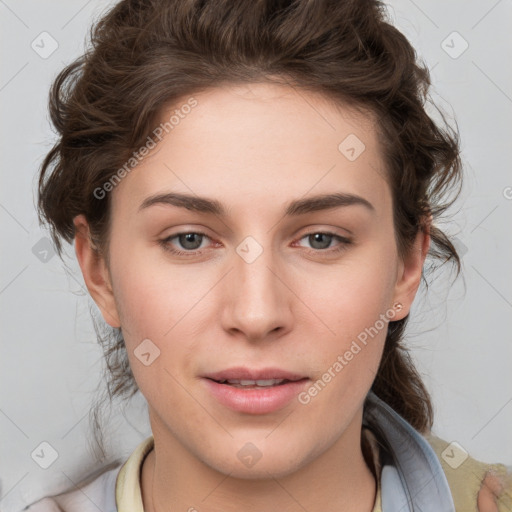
[{"xmin": 141, "ymin": 417, "xmax": 376, "ymax": 512}]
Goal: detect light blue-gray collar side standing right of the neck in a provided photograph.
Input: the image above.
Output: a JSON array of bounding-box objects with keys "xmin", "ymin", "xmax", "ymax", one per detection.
[{"xmin": 363, "ymin": 391, "xmax": 455, "ymax": 512}]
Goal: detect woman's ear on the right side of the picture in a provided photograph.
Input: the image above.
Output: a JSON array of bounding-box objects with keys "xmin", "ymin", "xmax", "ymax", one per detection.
[{"xmin": 393, "ymin": 217, "xmax": 432, "ymax": 320}]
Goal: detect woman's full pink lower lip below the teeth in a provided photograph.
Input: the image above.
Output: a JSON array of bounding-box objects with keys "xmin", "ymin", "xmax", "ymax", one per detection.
[{"xmin": 204, "ymin": 379, "xmax": 309, "ymax": 414}]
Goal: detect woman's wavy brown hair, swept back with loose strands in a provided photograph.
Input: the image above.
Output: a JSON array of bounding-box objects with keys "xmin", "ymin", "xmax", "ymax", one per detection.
[{"xmin": 38, "ymin": 0, "xmax": 461, "ymax": 456}]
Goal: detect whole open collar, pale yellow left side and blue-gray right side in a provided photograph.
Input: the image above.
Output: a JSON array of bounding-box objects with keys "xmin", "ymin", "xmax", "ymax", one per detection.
[{"xmin": 115, "ymin": 392, "xmax": 455, "ymax": 512}]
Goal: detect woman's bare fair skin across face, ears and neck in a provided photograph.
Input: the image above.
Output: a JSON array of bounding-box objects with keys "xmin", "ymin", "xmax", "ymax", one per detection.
[{"xmin": 75, "ymin": 83, "xmax": 429, "ymax": 512}]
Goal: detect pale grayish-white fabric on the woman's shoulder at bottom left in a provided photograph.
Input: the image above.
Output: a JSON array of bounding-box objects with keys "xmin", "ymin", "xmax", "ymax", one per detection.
[{"xmin": 23, "ymin": 464, "xmax": 121, "ymax": 512}]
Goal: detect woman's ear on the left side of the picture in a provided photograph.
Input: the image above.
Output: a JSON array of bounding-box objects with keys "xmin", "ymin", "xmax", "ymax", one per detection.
[{"xmin": 73, "ymin": 215, "xmax": 121, "ymax": 327}]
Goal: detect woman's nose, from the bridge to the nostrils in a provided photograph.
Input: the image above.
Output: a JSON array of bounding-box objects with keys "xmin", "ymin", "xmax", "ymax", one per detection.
[{"xmin": 221, "ymin": 239, "xmax": 293, "ymax": 342}]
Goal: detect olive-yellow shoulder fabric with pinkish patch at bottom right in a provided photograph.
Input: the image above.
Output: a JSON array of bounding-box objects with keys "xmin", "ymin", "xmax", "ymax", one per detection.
[{"xmin": 424, "ymin": 434, "xmax": 512, "ymax": 512}]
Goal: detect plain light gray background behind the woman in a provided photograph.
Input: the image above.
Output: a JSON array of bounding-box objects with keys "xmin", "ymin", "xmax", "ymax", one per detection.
[{"xmin": 0, "ymin": 0, "xmax": 512, "ymax": 511}]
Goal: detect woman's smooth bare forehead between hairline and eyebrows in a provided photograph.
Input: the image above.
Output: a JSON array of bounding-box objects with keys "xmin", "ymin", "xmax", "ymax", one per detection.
[{"xmin": 114, "ymin": 83, "xmax": 389, "ymax": 216}]
